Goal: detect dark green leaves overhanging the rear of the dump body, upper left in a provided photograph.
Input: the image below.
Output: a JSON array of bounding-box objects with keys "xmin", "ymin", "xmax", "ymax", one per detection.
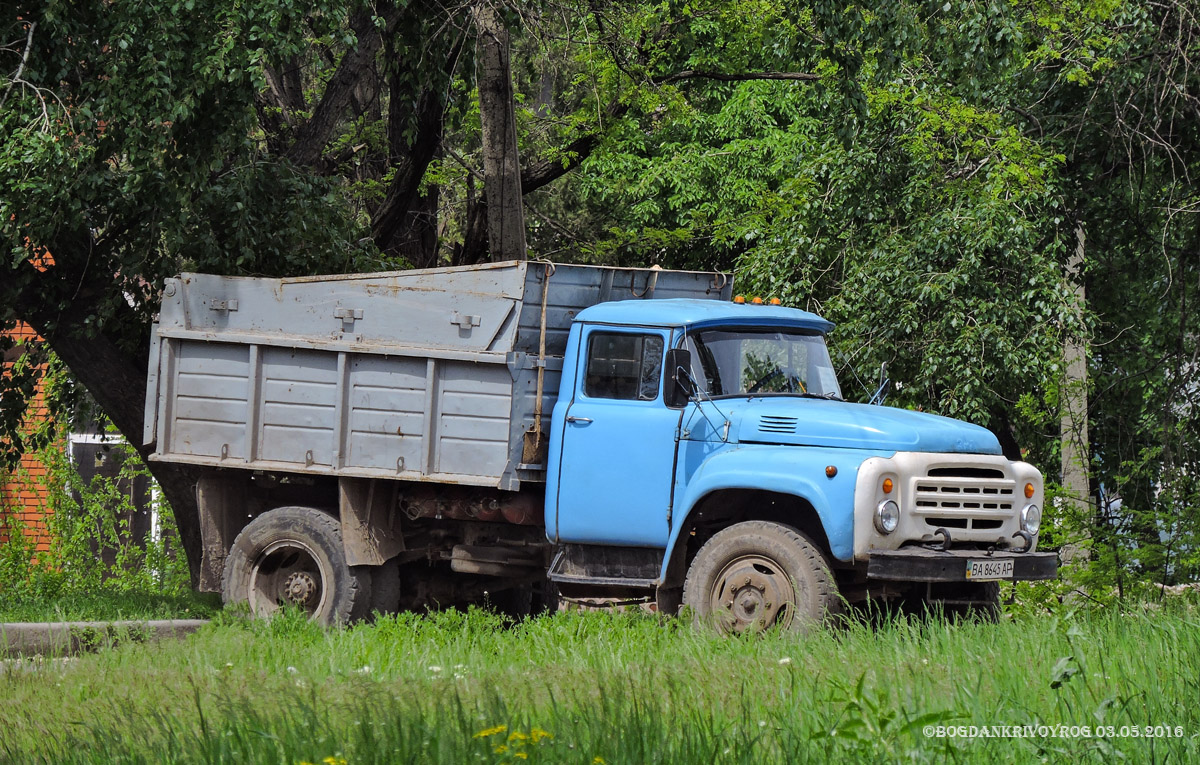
[{"xmin": 0, "ymin": 0, "xmax": 374, "ymax": 330}]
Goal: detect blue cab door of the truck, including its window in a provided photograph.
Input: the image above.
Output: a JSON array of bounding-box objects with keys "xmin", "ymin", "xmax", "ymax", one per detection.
[{"xmin": 557, "ymin": 326, "xmax": 679, "ymax": 547}]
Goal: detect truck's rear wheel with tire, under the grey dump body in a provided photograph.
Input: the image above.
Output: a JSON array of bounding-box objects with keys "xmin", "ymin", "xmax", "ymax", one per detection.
[{"xmin": 221, "ymin": 507, "xmax": 371, "ymax": 626}]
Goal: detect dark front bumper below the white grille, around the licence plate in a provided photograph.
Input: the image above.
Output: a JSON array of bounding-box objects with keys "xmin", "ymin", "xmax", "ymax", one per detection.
[{"xmin": 866, "ymin": 547, "xmax": 1058, "ymax": 582}]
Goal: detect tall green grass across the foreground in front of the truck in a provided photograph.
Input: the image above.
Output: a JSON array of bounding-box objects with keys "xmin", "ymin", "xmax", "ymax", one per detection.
[{"xmin": 0, "ymin": 604, "xmax": 1200, "ymax": 765}]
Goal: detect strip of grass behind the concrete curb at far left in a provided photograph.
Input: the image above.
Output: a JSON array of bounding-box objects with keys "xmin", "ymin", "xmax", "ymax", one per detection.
[{"xmin": 0, "ymin": 592, "xmax": 221, "ymax": 622}]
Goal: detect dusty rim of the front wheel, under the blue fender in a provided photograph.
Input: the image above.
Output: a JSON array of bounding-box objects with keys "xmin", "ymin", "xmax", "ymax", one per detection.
[{"xmin": 708, "ymin": 555, "xmax": 796, "ymax": 633}]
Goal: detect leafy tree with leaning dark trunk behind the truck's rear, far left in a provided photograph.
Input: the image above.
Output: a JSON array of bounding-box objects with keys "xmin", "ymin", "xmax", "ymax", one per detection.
[{"xmin": 0, "ymin": 1, "xmax": 379, "ymax": 580}]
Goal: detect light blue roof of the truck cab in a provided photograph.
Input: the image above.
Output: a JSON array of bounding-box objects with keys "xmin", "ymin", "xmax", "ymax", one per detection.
[{"xmin": 575, "ymin": 297, "xmax": 834, "ymax": 333}]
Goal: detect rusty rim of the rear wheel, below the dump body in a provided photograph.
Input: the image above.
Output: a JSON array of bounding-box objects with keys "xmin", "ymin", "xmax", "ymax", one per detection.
[{"xmin": 250, "ymin": 540, "xmax": 330, "ymax": 616}]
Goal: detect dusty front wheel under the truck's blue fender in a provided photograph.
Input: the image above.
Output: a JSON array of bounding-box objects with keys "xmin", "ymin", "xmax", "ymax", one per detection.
[{"xmin": 683, "ymin": 520, "xmax": 841, "ymax": 634}]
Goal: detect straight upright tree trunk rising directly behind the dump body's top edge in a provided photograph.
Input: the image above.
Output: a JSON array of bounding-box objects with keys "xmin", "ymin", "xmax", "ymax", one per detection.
[{"xmin": 473, "ymin": 4, "xmax": 526, "ymax": 260}]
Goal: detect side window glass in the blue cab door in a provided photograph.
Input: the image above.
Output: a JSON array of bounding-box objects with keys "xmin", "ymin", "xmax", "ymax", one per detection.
[{"xmin": 583, "ymin": 332, "xmax": 662, "ymax": 400}]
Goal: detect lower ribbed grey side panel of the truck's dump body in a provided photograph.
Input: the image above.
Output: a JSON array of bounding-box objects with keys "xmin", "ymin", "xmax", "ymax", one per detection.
[{"xmin": 157, "ymin": 339, "xmax": 512, "ymax": 486}]
